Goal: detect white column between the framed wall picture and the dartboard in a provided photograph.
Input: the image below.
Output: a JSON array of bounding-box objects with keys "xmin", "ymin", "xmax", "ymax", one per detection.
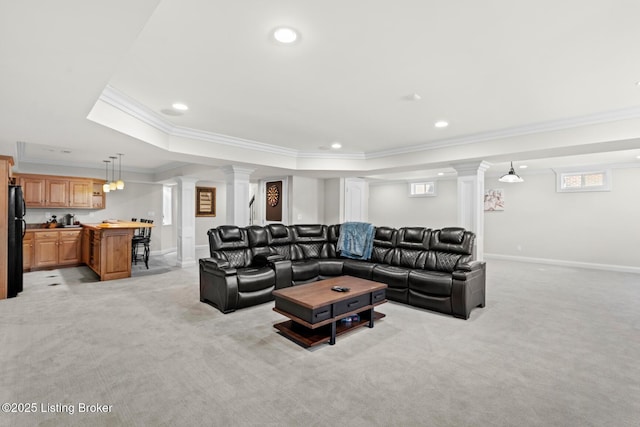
[{"xmin": 222, "ymin": 166, "xmax": 253, "ymax": 227}]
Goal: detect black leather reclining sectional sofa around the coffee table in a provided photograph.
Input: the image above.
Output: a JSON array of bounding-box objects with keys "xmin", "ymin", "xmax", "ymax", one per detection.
[{"xmin": 200, "ymin": 224, "xmax": 486, "ymax": 319}]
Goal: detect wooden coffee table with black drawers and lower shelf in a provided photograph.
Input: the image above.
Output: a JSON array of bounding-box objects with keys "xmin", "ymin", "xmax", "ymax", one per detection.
[{"xmin": 273, "ymin": 276, "xmax": 387, "ymax": 347}]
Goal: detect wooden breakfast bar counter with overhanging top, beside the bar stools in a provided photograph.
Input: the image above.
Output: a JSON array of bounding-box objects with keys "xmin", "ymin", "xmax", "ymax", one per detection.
[{"xmin": 82, "ymin": 221, "xmax": 153, "ymax": 280}]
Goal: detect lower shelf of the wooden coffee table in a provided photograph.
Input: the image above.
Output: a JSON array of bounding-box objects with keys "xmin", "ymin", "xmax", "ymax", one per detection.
[{"xmin": 273, "ymin": 309, "xmax": 385, "ymax": 347}]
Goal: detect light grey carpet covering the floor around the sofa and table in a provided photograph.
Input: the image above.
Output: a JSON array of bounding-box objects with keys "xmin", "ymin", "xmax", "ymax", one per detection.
[{"xmin": 0, "ymin": 261, "xmax": 640, "ymax": 427}]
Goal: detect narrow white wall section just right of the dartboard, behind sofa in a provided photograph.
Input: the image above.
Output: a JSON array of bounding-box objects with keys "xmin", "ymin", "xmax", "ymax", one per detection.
[{"xmin": 290, "ymin": 176, "xmax": 325, "ymax": 224}]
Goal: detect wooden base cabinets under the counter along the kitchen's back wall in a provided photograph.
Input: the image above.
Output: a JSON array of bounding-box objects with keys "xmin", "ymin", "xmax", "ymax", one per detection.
[{"xmin": 32, "ymin": 229, "xmax": 82, "ymax": 268}]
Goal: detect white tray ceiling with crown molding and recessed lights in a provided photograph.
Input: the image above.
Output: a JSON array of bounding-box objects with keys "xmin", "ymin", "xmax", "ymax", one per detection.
[{"xmin": 0, "ymin": 0, "xmax": 640, "ymax": 179}]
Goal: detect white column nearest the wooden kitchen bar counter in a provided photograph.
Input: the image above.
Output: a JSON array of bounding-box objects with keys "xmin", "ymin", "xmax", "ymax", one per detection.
[{"xmin": 176, "ymin": 176, "xmax": 198, "ymax": 268}]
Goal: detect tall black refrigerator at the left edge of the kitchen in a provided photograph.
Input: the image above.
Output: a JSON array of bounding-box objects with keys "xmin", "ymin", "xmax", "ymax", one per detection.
[{"xmin": 7, "ymin": 185, "xmax": 27, "ymax": 298}]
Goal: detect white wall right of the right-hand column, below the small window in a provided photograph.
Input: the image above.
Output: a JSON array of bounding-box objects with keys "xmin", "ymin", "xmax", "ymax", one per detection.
[{"xmin": 485, "ymin": 168, "xmax": 640, "ymax": 267}]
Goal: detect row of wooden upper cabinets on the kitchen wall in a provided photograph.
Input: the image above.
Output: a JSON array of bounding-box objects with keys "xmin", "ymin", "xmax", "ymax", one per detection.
[{"xmin": 16, "ymin": 174, "xmax": 106, "ymax": 209}]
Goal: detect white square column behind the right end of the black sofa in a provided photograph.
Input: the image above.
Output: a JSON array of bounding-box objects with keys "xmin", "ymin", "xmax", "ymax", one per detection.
[{"xmin": 451, "ymin": 161, "xmax": 490, "ymax": 261}]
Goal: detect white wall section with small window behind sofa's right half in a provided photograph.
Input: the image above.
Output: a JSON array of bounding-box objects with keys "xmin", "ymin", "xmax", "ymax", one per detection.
[{"xmin": 369, "ymin": 179, "xmax": 458, "ymax": 228}]
